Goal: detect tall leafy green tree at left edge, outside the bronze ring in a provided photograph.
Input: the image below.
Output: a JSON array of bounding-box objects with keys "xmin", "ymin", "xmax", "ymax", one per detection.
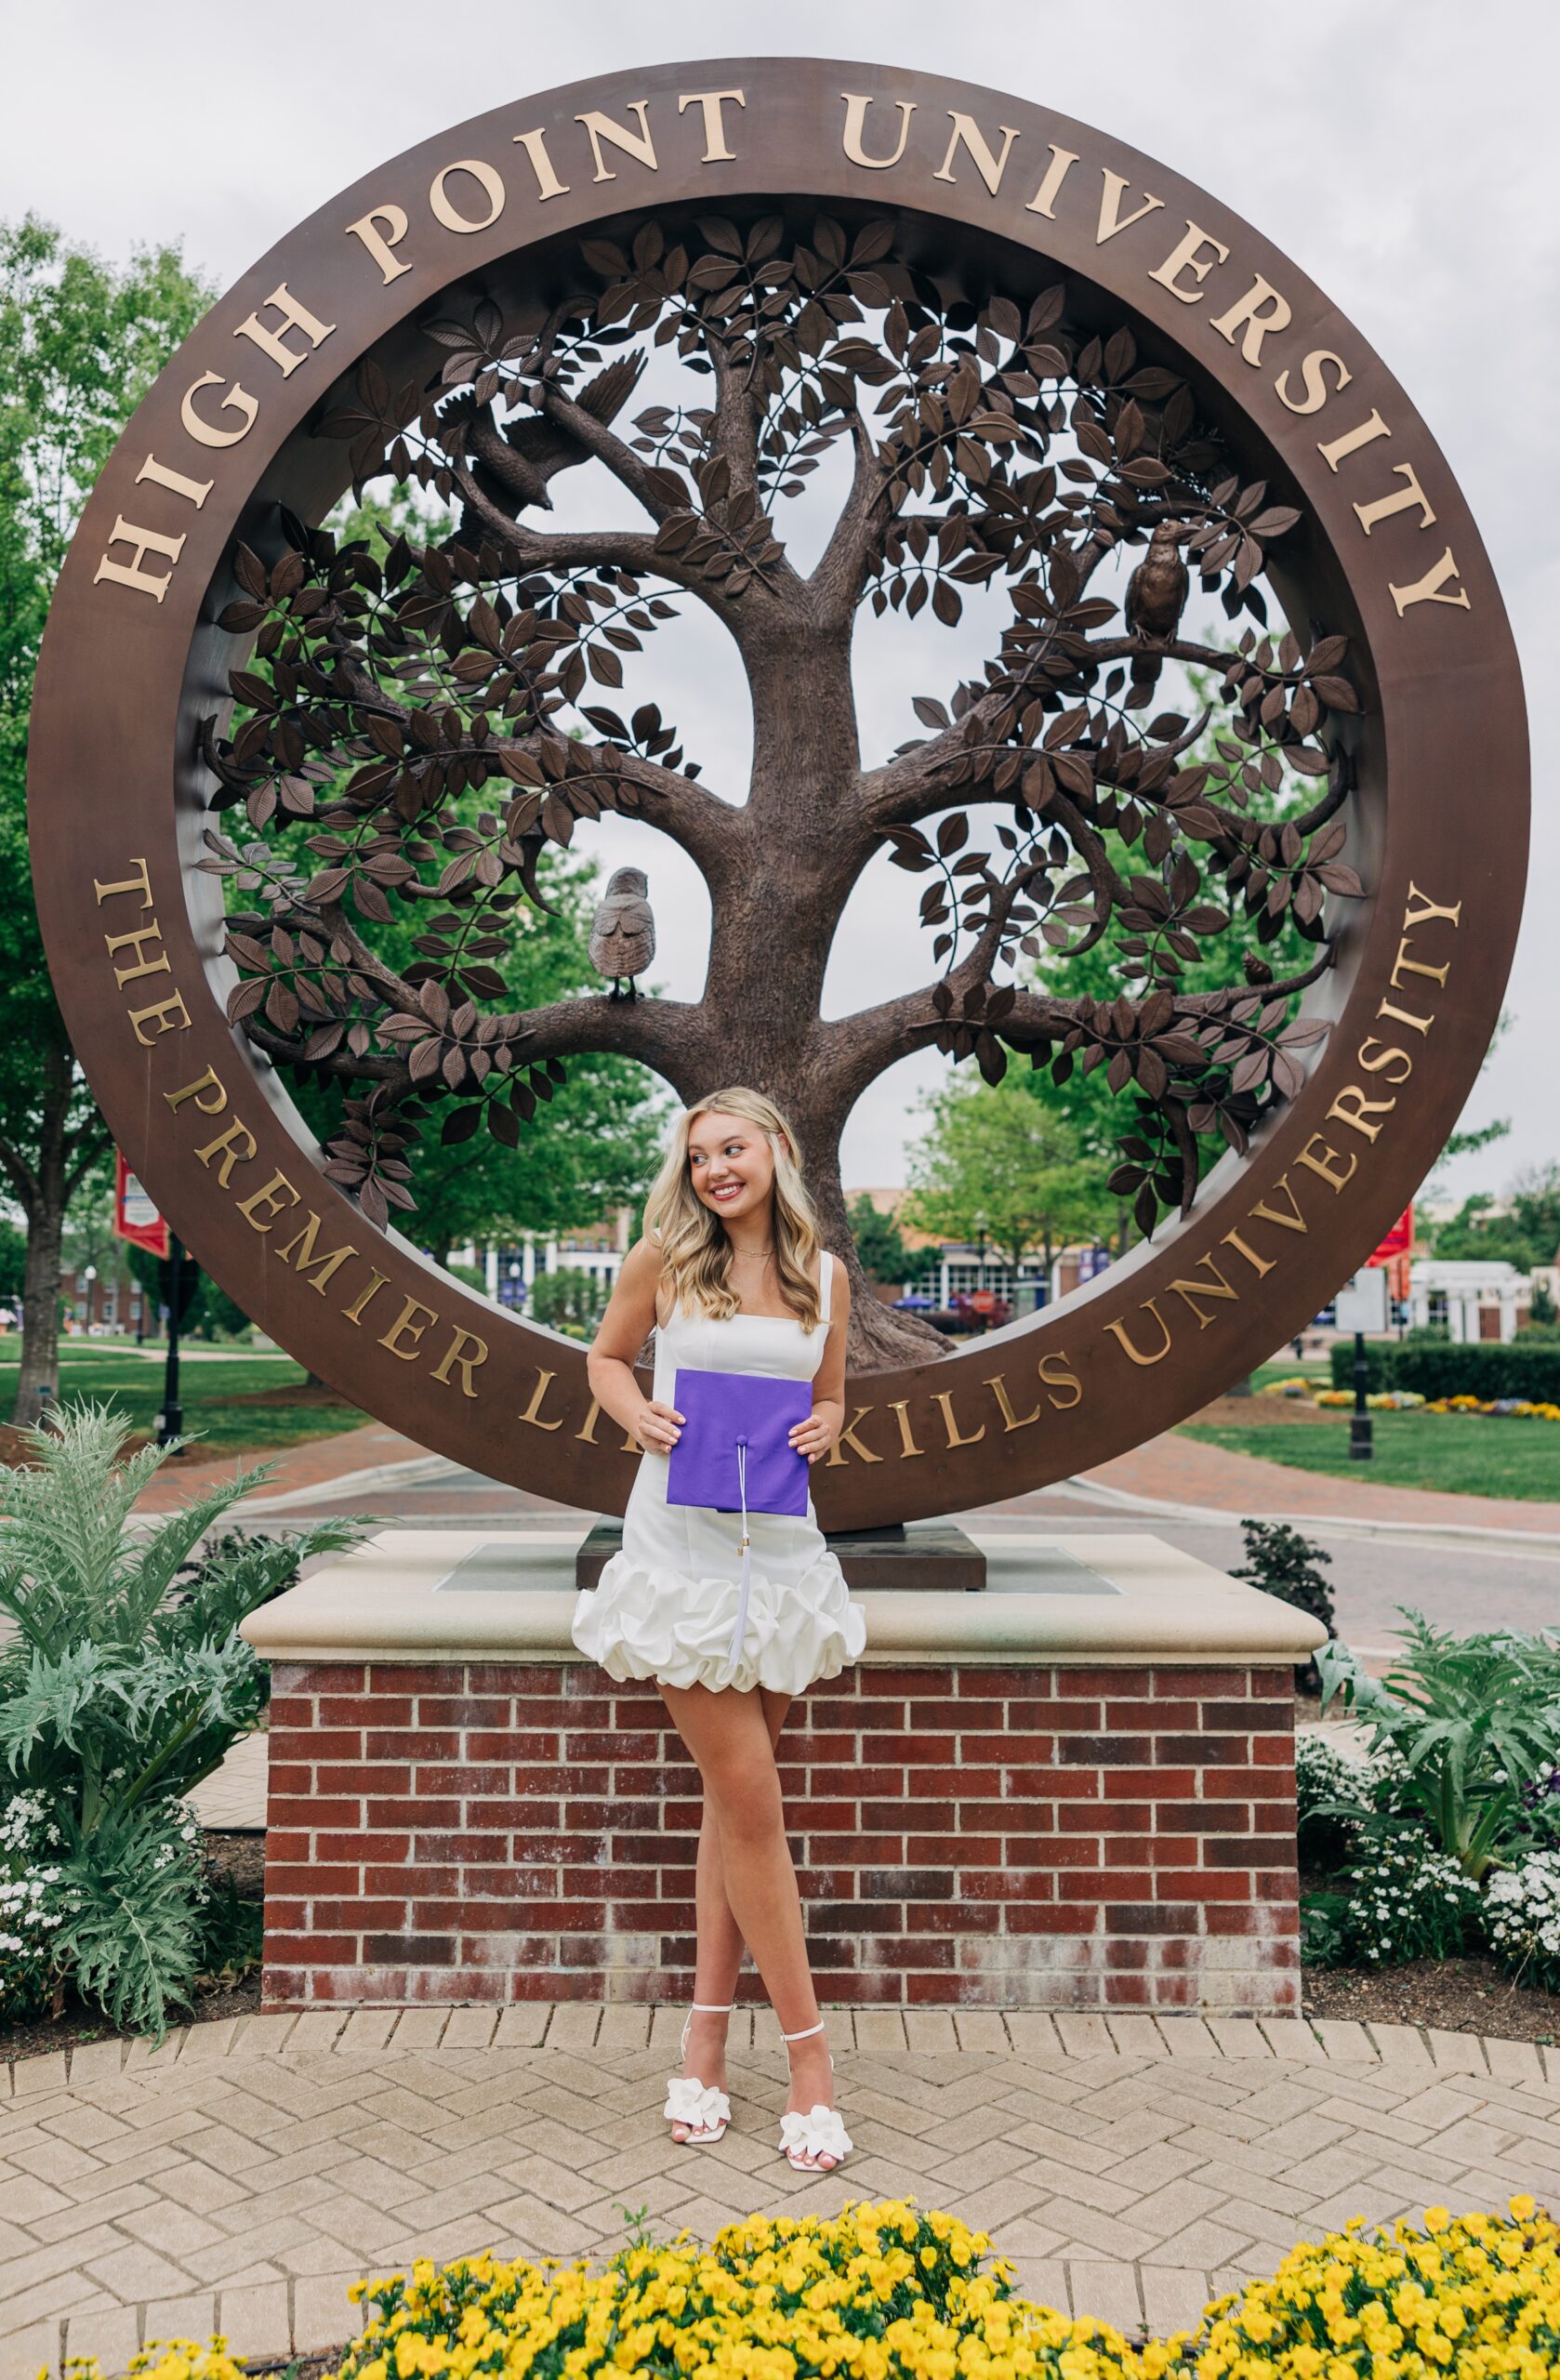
[{"xmin": 0, "ymin": 217, "xmax": 212, "ymax": 1421}]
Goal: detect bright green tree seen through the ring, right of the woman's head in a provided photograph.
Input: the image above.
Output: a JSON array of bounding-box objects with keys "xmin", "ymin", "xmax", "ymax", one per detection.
[{"xmin": 905, "ymin": 1076, "xmax": 1112, "ymax": 1274}]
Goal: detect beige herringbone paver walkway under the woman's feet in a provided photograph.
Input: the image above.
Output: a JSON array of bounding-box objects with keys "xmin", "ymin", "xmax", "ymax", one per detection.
[{"xmin": 0, "ymin": 2004, "xmax": 1560, "ymax": 2380}]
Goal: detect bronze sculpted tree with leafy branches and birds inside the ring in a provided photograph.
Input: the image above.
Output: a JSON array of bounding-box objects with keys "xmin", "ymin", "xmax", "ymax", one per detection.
[{"xmin": 203, "ymin": 212, "xmax": 1360, "ymax": 1368}]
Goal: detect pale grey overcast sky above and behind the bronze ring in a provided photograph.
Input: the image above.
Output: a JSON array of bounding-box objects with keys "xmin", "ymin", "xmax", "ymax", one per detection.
[{"xmin": 0, "ymin": 0, "xmax": 1560, "ymax": 1193}]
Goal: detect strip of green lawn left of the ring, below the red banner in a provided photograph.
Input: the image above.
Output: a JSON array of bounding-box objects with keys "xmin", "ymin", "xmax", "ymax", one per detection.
[{"xmin": 0, "ymin": 1333, "xmax": 364, "ymax": 1454}]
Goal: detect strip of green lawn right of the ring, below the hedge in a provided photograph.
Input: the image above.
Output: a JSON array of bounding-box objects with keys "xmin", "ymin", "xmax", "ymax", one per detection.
[{"xmin": 1186, "ymin": 1411, "xmax": 1560, "ymax": 1504}]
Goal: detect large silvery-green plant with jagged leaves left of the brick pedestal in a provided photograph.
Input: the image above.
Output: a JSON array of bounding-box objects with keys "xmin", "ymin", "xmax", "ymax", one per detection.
[{"xmin": 0, "ymin": 1404, "xmax": 360, "ymax": 2035}]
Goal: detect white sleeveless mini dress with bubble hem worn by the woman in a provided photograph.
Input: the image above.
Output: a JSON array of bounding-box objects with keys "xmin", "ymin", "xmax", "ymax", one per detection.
[{"xmin": 569, "ymin": 1254, "xmax": 867, "ymax": 1695}]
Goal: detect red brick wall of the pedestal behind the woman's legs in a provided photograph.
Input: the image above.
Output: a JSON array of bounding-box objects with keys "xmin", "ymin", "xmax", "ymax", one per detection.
[{"xmin": 264, "ymin": 1661, "xmax": 1301, "ymax": 2014}]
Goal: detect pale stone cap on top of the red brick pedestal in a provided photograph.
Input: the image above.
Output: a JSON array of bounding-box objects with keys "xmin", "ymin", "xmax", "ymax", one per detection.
[{"xmin": 243, "ymin": 1523, "xmax": 1327, "ymax": 1669}]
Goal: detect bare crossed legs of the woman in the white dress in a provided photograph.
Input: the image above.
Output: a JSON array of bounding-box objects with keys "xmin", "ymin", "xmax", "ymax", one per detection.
[{"xmin": 662, "ymin": 1685, "xmax": 834, "ymax": 2171}]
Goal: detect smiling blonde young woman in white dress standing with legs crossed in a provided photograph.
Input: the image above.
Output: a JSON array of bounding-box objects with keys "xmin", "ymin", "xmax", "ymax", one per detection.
[{"xmin": 572, "ymin": 1088, "xmax": 867, "ymax": 2173}]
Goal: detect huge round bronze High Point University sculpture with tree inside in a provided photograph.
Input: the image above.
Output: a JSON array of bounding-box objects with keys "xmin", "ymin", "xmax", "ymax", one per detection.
[{"xmin": 31, "ymin": 60, "xmax": 1527, "ymax": 1528}]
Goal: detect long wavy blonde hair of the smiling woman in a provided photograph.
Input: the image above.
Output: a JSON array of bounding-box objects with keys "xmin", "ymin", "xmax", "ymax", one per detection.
[{"xmin": 645, "ymin": 1083, "xmax": 824, "ymax": 1330}]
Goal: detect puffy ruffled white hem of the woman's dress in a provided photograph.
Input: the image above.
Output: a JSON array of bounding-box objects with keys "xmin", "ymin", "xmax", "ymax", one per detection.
[{"xmin": 569, "ymin": 1552, "xmax": 867, "ymax": 1695}]
